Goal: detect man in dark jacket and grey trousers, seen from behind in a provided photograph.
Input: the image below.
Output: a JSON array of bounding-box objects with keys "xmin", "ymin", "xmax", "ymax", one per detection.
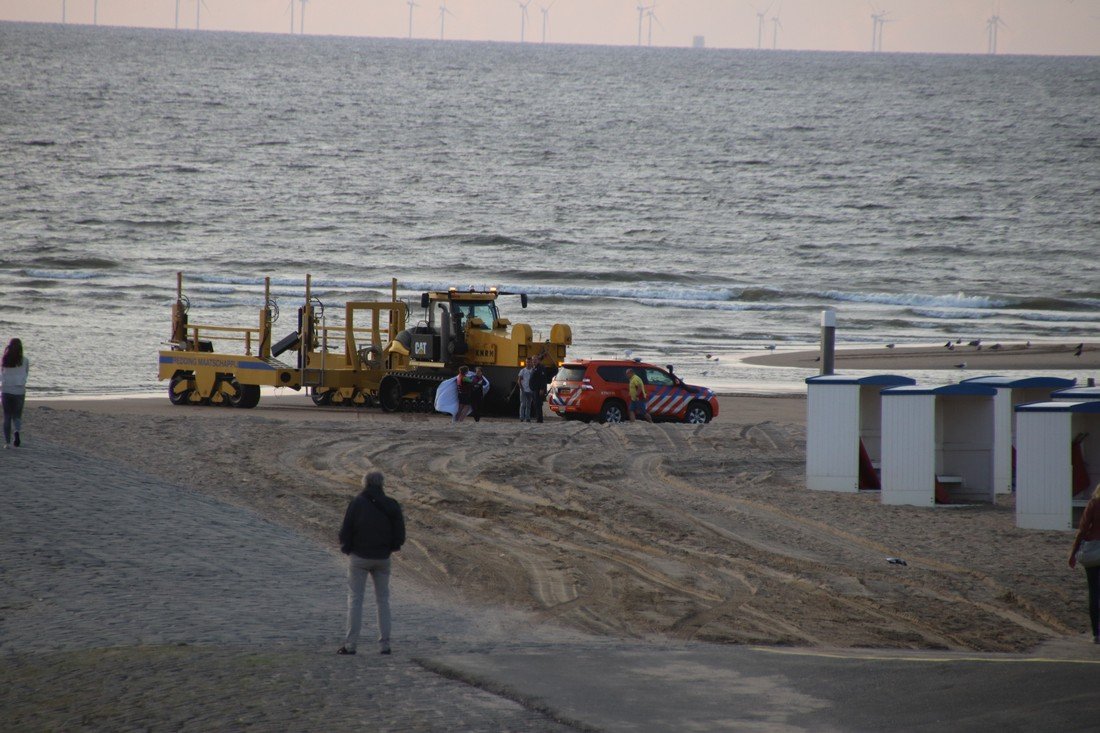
[{"xmin": 337, "ymin": 471, "xmax": 405, "ymax": 654}]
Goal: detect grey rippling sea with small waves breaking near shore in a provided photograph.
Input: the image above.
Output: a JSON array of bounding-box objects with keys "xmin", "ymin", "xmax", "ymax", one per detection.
[{"xmin": 0, "ymin": 23, "xmax": 1100, "ymax": 397}]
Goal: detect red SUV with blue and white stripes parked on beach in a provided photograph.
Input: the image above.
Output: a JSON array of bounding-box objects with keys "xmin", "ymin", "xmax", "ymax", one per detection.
[{"xmin": 548, "ymin": 359, "xmax": 718, "ymax": 424}]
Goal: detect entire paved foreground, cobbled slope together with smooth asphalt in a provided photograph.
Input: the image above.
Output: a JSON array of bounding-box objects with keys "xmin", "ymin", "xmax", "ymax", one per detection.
[{"xmin": 0, "ymin": 435, "xmax": 1100, "ymax": 731}]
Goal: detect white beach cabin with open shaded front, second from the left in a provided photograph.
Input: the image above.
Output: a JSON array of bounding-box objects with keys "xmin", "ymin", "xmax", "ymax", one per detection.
[{"xmin": 881, "ymin": 383, "xmax": 997, "ymax": 506}]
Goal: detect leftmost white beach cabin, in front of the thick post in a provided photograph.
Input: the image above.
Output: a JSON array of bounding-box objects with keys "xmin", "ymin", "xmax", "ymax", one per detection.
[{"xmin": 806, "ymin": 374, "xmax": 916, "ymax": 491}]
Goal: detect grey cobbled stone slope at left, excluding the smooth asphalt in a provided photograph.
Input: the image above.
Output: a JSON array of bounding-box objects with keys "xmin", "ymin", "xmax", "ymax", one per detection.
[{"xmin": 0, "ymin": 445, "xmax": 580, "ymax": 731}]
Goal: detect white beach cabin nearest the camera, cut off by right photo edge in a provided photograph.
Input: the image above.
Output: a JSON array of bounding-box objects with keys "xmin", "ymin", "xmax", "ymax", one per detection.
[{"xmin": 1016, "ymin": 400, "xmax": 1100, "ymax": 529}]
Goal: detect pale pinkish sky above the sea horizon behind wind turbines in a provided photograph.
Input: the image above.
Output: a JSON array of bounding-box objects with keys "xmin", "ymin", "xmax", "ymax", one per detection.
[{"xmin": 0, "ymin": 0, "xmax": 1100, "ymax": 55}]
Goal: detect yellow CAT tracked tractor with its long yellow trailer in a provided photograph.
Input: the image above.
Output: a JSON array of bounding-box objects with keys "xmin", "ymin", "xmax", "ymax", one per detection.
[{"xmin": 158, "ymin": 273, "xmax": 572, "ymax": 413}]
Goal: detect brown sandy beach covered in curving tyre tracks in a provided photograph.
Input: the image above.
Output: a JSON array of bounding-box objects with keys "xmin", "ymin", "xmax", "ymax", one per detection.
[{"xmin": 15, "ymin": 387, "xmax": 1084, "ymax": 652}]
